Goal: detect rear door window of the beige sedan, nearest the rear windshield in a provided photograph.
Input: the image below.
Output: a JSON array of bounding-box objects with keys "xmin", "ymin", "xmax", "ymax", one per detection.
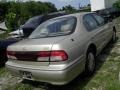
[{"xmin": 83, "ymin": 15, "xmax": 98, "ymax": 31}]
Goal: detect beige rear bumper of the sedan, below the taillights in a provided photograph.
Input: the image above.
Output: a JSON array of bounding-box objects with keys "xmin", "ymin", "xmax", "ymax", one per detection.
[{"xmin": 6, "ymin": 58, "xmax": 84, "ymax": 85}]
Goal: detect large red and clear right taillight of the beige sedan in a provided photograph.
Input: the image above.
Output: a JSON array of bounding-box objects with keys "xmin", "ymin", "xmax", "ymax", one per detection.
[{"xmin": 37, "ymin": 50, "xmax": 68, "ymax": 62}]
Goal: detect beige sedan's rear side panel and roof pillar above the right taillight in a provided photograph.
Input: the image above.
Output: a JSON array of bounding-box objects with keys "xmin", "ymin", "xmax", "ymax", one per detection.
[{"xmin": 51, "ymin": 16, "xmax": 89, "ymax": 67}]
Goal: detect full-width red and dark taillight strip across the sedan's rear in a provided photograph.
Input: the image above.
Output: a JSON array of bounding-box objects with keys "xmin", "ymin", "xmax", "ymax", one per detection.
[{"xmin": 7, "ymin": 50, "xmax": 68, "ymax": 62}]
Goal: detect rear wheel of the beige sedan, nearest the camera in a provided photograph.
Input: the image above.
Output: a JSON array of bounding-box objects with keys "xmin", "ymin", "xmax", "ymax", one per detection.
[{"xmin": 85, "ymin": 50, "xmax": 96, "ymax": 76}]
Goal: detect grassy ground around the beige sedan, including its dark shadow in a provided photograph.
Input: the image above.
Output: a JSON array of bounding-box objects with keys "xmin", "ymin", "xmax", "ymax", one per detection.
[{"xmin": 0, "ymin": 18, "xmax": 120, "ymax": 90}]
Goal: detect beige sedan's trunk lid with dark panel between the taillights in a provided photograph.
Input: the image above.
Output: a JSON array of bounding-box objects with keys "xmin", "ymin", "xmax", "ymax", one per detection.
[{"xmin": 7, "ymin": 36, "xmax": 67, "ymax": 64}]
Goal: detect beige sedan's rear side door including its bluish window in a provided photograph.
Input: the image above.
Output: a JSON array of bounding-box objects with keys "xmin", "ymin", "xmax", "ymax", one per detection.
[{"xmin": 84, "ymin": 14, "xmax": 105, "ymax": 51}]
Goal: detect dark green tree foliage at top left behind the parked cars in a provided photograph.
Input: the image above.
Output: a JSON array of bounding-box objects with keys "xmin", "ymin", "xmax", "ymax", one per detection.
[{"xmin": 0, "ymin": 1, "xmax": 57, "ymax": 30}]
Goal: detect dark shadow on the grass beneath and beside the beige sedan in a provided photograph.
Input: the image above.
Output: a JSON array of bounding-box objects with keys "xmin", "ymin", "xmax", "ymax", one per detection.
[{"xmin": 22, "ymin": 39, "xmax": 118, "ymax": 90}]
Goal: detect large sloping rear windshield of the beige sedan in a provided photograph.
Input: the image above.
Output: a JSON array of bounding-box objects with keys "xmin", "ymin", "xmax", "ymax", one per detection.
[{"xmin": 29, "ymin": 17, "xmax": 77, "ymax": 38}]
